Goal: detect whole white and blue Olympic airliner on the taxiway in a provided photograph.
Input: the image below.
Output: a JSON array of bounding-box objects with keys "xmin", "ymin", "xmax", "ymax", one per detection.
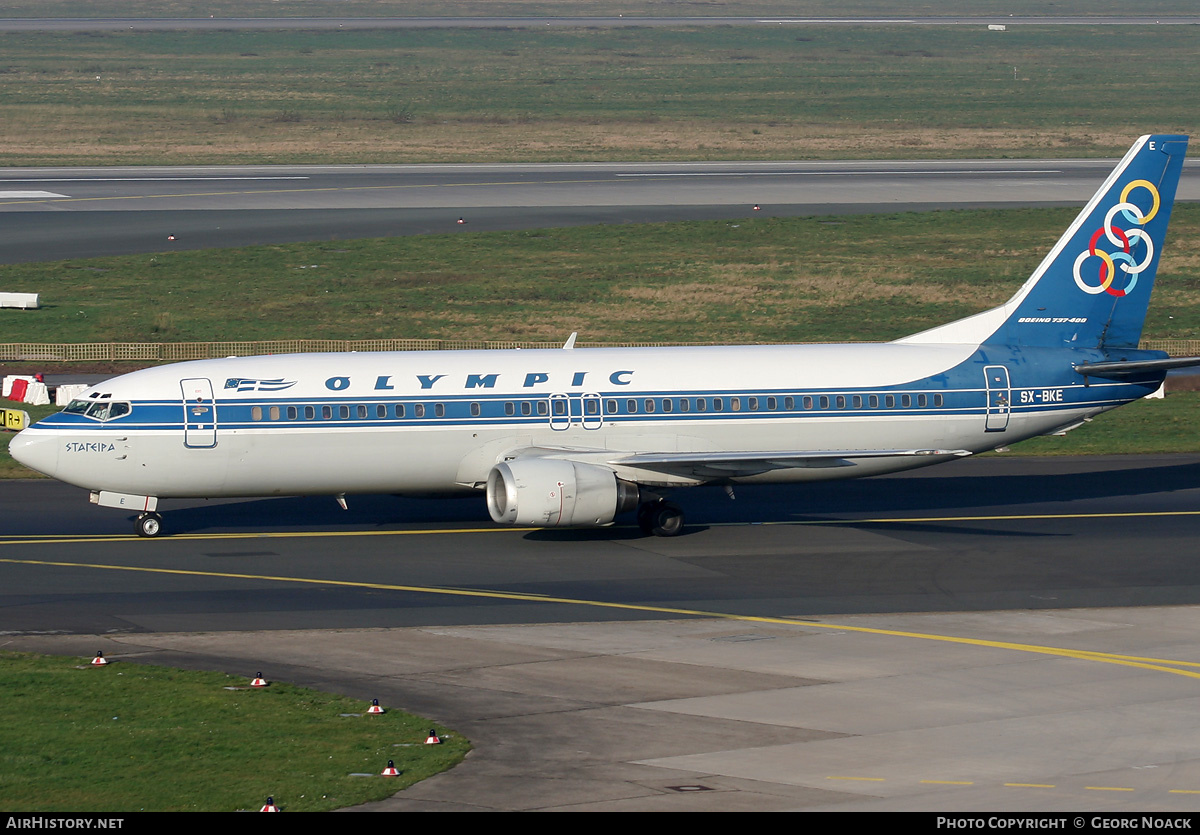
[{"xmin": 10, "ymin": 136, "xmax": 1200, "ymax": 536}]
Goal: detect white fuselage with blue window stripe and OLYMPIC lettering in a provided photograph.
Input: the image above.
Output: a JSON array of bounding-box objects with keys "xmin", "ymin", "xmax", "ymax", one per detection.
[{"xmin": 9, "ymin": 343, "xmax": 1145, "ymax": 497}]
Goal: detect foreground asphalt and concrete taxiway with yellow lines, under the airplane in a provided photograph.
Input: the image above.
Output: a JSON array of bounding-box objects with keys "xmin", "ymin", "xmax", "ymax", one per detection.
[{"xmin": 7, "ymin": 456, "xmax": 1200, "ymax": 811}]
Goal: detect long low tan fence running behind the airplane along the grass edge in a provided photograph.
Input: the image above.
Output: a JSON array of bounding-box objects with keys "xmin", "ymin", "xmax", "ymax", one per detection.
[{"xmin": 0, "ymin": 340, "xmax": 1200, "ymax": 362}]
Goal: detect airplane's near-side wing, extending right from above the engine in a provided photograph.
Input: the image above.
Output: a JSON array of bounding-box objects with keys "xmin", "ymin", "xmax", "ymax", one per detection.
[{"xmin": 607, "ymin": 449, "xmax": 971, "ymax": 479}]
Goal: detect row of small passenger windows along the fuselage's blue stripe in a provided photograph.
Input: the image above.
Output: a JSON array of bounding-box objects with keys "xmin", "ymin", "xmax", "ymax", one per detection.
[{"xmin": 250, "ymin": 394, "xmax": 942, "ymax": 421}]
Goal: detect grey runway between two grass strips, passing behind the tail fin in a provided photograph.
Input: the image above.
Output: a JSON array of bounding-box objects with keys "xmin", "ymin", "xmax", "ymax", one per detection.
[{"xmin": 0, "ymin": 160, "xmax": 1200, "ymax": 264}]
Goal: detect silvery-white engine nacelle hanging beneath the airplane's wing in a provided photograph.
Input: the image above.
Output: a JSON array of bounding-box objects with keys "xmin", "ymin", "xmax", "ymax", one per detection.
[{"xmin": 487, "ymin": 458, "xmax": 637, "ymax": 528}]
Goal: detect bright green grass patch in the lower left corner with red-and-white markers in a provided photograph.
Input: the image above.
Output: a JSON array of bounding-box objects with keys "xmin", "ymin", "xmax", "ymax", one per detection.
[{"xmin": 0, "ymin": 653, "xmax": 470, "ymax": 812}]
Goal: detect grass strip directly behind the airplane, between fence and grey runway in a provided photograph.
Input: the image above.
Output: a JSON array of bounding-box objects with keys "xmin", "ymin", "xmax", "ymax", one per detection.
[{"xmin": 0, "ymin": 204, "xmax": 1200, "ymax": 343}]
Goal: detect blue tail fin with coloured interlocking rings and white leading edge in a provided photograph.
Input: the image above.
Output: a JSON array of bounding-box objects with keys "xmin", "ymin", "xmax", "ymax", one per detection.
[{"xmin": 900, "ymin": 134, "xmax": 1188, "ymax": 348}]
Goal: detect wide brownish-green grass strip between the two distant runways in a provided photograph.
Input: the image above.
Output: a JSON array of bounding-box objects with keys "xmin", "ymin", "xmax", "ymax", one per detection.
[{"xmin": 0, "ymin": 25, "xmax": 1200, "ymax": 166}]
